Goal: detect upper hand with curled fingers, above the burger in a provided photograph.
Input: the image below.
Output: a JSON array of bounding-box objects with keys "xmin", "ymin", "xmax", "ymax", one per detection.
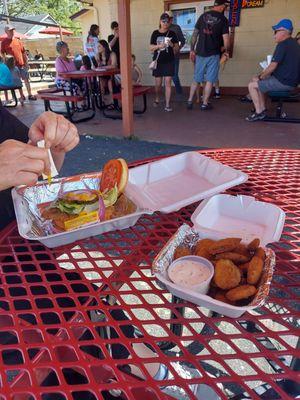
[{"xmin": 28, "ymin": 111, "xmax": 79, "ymax": 153}]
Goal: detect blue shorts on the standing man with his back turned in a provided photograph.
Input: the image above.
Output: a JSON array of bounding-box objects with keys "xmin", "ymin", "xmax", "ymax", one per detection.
[{"xmin": 194, "ymin": 54, "xmax": 220, "ymax": 83}]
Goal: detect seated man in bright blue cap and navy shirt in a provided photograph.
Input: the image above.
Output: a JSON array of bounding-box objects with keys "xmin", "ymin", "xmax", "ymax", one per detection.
[{"xmin": 246, "ymin": 19, "xmax": 300, "ymax": 122}]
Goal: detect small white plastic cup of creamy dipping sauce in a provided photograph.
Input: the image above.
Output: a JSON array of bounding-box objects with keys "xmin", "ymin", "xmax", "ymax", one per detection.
[{"xmin": 168, "ymin": 256, "xmax": 215, "ymax": 294}]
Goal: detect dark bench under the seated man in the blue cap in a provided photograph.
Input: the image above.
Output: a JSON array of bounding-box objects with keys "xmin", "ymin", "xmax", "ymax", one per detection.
[{"xmin": 264, "ymin": 91, "xmax": 300, "ymax": 124}]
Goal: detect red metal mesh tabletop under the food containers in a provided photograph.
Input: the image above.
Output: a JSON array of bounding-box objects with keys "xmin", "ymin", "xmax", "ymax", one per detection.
[{"xmin": 0, "ymin": 149, "xmax": 300, "ymax": 400}]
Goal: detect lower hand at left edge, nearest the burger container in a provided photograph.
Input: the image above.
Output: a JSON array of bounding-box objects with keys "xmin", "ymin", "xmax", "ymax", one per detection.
[{"xmin": 0, "ymin": 140, "xmax": 50, "ymax": 190}]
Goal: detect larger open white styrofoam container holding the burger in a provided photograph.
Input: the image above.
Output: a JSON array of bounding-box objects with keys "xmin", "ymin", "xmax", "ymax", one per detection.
[{"xmin": 12, "ymin": 152, "xmax": 248, "ymax": 248}]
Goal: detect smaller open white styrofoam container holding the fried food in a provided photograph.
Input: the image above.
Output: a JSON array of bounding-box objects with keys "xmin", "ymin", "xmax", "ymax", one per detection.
[{"xmin": 154, "ymin": 194, "xmax": 285, "ymax": 318}]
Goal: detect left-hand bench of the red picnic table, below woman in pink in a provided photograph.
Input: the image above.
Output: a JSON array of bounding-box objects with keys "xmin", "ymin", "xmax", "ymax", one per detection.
[{"xmin": 38, "ymin": 87, "xmax": 95, "ymax": 123}]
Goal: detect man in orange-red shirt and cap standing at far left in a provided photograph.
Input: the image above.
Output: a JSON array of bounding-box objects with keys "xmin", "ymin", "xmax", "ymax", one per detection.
[{"xmin": 1, "ymin": 25, "xmax": 37, "ymax": 100}]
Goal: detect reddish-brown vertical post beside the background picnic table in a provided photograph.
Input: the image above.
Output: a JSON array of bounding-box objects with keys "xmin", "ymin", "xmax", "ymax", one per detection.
[{"xmin": 118, "ymin": 0, "xmax": 133, "ymax": 137}]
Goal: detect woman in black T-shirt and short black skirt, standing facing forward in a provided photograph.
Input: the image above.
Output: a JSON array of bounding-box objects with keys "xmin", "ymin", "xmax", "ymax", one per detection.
[{"xmin": 150, "ymin": 13, "xmax": 179, "ymax": 112}]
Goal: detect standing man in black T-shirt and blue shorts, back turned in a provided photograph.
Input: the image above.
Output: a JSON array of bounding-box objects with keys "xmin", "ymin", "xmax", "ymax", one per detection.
[{"xmin": 187, "ymin": 0, "xmax": 229, "ymax": 111}]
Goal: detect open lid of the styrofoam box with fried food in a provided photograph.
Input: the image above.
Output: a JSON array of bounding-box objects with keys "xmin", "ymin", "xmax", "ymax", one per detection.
[{"xmin": 191, "ymin": 194, "xmax": 285, "ymax": 246}]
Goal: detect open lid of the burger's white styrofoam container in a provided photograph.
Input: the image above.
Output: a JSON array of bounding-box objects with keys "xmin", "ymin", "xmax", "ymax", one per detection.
[{"xmin": 127, "ymin": 151, "xmax": 248, "ymax": 213}]
